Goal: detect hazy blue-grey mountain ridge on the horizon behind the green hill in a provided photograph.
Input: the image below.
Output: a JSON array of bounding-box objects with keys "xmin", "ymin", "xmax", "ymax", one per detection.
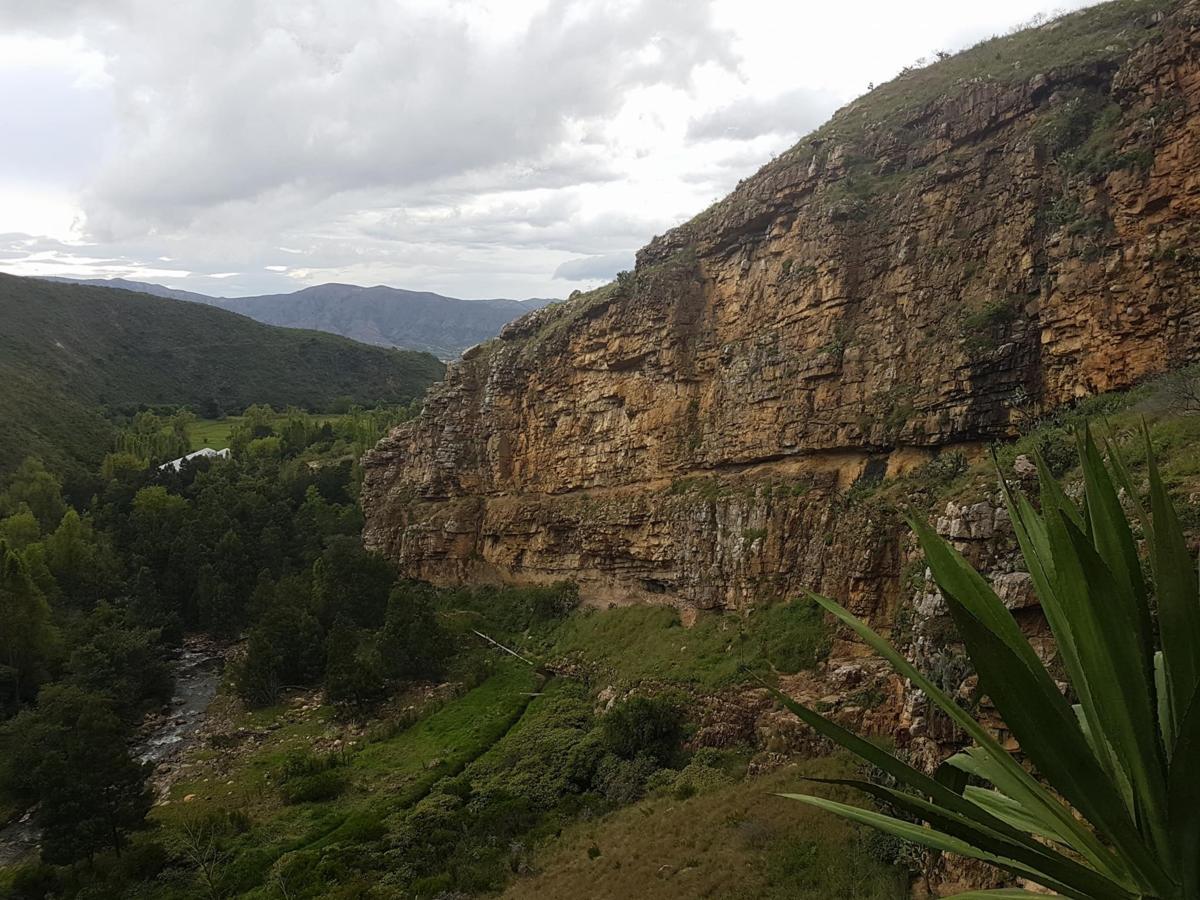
[{"xmin": 43, "ymin": 278, "xmax": 553, "ymax": 360}]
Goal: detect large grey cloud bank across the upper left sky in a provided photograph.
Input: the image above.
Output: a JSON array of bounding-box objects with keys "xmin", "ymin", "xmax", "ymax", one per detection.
[{"xmin": 0, "ymin": 0, "xmax": 736, "ymax": 236}]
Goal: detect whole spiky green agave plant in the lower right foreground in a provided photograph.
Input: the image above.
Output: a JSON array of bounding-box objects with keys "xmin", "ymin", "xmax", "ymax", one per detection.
[{"xmin": 780, "ymin": 430, "xmax": 1200, "ymax": 900}]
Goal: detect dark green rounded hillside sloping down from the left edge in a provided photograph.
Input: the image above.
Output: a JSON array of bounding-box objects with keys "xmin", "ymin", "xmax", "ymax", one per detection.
[{"xmin": 0, "ymin": 275, "xmax": 444, "ymax": 473}]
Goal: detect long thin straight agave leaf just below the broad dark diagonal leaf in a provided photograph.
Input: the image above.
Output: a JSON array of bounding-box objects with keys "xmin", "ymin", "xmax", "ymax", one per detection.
[{"xmin": 810, "ymin": 594, "xmax": 1124, "ymax": 878}]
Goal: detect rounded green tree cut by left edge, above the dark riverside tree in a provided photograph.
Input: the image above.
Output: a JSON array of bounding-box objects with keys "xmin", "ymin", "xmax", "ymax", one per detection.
[{"xmin": 0, "ymin": 541, "xmax": 58, "ymax": 715}]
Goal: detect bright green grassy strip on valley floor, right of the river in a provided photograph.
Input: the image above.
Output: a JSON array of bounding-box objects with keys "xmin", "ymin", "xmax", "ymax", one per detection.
[{"xmin": 146, "ymin": 662, "xmax": 536, "ymax": 896}]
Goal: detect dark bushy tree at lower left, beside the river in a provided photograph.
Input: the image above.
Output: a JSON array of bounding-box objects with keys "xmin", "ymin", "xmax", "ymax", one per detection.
[{"xmin": 2, "ymin": 684, "xmax": 151, "ymax": 864}]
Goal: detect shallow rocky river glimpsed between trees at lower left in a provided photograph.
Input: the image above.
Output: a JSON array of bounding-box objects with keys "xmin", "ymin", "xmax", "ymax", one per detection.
[{"xmin": 0, "ymin": 638, "xmax": 224, "ymax": 865}]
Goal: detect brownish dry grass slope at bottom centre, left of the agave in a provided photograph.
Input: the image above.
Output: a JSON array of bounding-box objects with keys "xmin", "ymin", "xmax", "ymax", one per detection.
[{"xmin": 503, "ymin": 757, "xmax": 907, "ymax": 900}]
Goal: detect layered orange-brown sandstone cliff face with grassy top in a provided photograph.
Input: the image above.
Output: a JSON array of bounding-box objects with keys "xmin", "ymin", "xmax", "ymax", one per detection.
[{"xmin": 362, "ymin": 2, "xmax": 1200, "ymax": 622}]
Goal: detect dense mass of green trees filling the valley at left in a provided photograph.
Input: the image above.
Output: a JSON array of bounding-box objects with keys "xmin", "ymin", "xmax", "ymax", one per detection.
[{"xmin": 0, "ymin": 407, "xmax": 432, "ymax": 863}]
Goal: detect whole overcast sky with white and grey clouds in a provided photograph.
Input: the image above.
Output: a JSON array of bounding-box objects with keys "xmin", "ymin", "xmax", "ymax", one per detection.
[{"xmin": 0, "ymin": 0, "xmax": 1090, "ymax": 298}]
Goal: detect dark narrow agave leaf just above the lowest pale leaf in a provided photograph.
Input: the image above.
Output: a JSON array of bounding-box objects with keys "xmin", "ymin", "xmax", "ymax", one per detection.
[{"xmin": 805, "ymin": 778, "xmax": 1128, "ymax": 900}]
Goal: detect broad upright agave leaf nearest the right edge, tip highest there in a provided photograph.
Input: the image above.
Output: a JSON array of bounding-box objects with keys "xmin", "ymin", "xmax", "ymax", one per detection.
[{"xmin": 1144, "ymin": 426, "xmax": 1200, "ymax": 734}]
